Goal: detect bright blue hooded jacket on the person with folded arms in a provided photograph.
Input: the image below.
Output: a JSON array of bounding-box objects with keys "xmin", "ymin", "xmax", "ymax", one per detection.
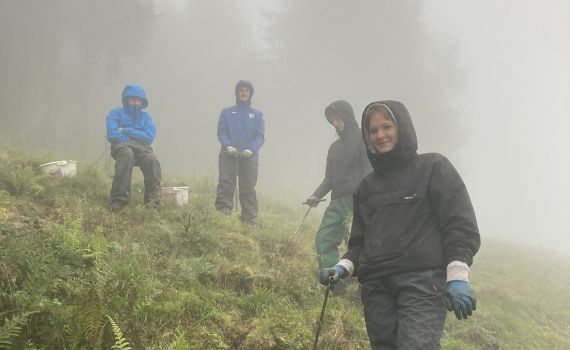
[{"xmin": 107, "ymin": 85, "xmax": 156, "ymax": 145}]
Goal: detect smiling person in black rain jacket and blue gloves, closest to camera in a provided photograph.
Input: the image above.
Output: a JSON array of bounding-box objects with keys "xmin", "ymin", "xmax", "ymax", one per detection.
[{"xmin": 320, "ymin": 101, "xmax": 480, "ymax": 349}]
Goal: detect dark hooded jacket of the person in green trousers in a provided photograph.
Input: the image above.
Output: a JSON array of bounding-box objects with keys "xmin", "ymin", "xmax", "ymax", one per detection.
[{"xmin": 312, "ymin": 100, "xmax": 372, "ymax": 199}]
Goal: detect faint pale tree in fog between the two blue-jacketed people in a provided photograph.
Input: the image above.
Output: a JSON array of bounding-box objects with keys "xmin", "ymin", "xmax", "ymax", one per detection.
[{"xmin": 137, "ymin": 0, "xmax": 260, "ymax": 173}]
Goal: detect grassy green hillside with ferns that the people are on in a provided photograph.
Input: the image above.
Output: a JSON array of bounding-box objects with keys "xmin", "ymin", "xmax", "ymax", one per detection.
[{"xmin": 0, "ymin": 146, "xmax": 570, "ymax": 349}]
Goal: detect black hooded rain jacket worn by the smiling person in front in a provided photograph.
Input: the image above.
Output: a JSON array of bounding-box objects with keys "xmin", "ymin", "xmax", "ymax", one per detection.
[{"xmin": 343, "ymin": 101, "xmax": 480, "ymax": 282}]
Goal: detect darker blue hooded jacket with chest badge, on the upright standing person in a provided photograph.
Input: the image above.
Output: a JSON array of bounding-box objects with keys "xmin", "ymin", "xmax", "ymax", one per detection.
[{"xmin": 218, "ymin": 80, "xmax": 265, "ymax": 162}]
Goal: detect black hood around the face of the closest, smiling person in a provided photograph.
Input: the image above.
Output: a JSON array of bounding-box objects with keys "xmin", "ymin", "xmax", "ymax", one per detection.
[{"xmin": 361, "ymin": 101, "xmax": 418, "ymax": 173}]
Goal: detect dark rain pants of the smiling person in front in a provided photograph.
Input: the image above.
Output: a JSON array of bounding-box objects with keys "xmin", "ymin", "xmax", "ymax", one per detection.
[{"xmin": 361, "ymin": 268, "xmax": 447, "ymax": 350}]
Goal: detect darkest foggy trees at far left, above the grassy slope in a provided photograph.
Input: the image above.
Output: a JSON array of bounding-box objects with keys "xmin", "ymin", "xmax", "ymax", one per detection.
[{"xmin": 0, "ymin": 0, "xmax": 154, "ymax": 152}]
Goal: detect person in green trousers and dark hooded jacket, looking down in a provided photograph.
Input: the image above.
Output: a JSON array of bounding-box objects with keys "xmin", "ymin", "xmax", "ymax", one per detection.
[{"xmin": 305, "ymin": 100, "xmax": 372, "ymax": 294}]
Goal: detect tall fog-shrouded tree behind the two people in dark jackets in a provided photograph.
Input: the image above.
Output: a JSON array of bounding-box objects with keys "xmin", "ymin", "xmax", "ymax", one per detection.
[{"xmin": 266, "ymin": 0, "xmax": 463, "ymax": 152}]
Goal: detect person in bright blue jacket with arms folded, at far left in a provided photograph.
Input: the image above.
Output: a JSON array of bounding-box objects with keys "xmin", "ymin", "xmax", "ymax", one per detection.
[{"xmin": 107, "ymin": 85, "xmax": 161, "ymax": 212}]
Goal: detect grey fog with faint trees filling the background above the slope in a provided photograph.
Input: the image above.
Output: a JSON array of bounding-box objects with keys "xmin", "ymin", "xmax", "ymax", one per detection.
[{"xmin": 0, "ymin": 0, "xmax": 570, "ymax": 253}]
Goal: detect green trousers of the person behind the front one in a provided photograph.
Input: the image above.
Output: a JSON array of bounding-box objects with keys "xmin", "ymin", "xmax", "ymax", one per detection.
[{"xmin": 315, "ymin": 195, "xmax": 352, "ymax": 269}]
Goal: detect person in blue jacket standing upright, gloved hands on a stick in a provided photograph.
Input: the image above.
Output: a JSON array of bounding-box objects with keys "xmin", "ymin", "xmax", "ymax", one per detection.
[{"xmin": 215, "ymin": 80, "xmax": 265, "ymax": 225}]
